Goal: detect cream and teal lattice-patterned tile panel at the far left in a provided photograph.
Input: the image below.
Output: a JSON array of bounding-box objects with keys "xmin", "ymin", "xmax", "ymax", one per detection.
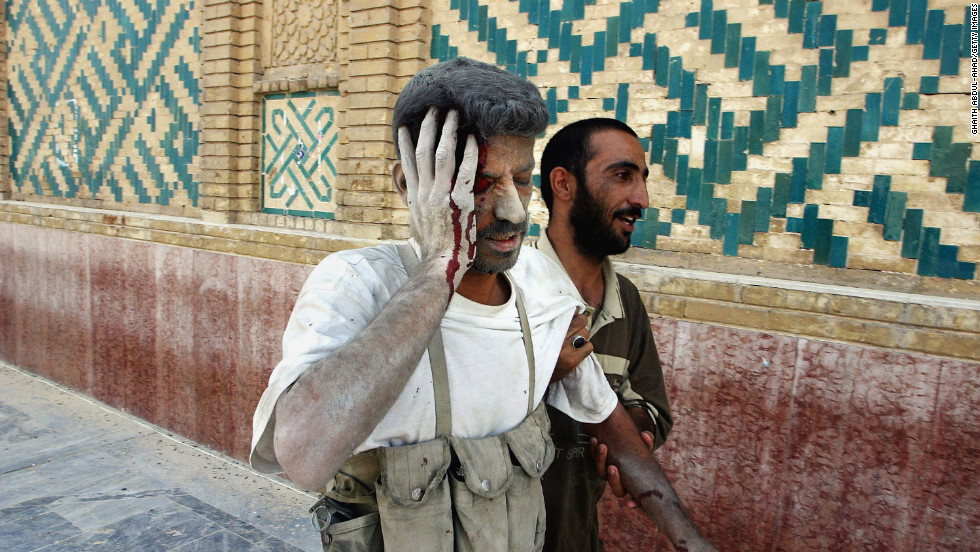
[{"xmin": 6, "ymin": 0, "xmax": 201, "ymax": 206}]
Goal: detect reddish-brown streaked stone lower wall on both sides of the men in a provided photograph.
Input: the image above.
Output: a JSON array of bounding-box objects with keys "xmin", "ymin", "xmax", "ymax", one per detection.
[{"xmin": 0, "ymin": 223, "xmax": 980, "ymax": 552}]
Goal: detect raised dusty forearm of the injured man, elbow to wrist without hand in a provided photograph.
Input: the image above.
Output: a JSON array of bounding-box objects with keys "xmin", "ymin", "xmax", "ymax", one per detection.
[{"xmin": 275, "ymin": 262, "xmax": 450, "ymax": 491}]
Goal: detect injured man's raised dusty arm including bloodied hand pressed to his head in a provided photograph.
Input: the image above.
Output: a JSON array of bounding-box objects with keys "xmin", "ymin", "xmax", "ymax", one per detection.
[{"xmin": 274, "ymin": 110, "xmax": 477, "ymax": 491}]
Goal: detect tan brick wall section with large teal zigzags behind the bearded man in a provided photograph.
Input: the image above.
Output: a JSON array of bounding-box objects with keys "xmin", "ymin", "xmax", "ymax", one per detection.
[{"xmin": 431, "ymin": 0, "xmax": 980, "ymax": 280}]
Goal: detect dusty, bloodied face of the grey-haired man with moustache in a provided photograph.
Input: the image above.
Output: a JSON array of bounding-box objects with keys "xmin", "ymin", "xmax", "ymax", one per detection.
[{"xmin": 472, "ymin": 135, "xmax": 534, "ymax": 274}]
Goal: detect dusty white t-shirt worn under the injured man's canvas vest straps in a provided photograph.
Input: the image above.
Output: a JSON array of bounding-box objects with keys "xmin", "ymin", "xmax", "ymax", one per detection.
[{"xmin": 250, "ymin": 244, "xmax": 617, "ymax": 473}]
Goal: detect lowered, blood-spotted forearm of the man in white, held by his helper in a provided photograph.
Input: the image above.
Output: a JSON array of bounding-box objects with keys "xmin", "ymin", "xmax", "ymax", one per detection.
[{"xmin": 585, "ymin": 404, "xmax": 716, "ymax": 552}]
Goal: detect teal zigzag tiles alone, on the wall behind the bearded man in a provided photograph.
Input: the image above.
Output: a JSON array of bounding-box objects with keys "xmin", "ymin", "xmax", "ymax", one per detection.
[{"xmin": 431, "ymin": 0, "xmax": 980, "ymax": 279}]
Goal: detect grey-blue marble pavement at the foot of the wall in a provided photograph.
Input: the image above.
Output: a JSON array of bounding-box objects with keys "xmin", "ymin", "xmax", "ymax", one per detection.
[{"xmin": 0, "ymin": 363, "xmax": 321, "ymax": 552}]
